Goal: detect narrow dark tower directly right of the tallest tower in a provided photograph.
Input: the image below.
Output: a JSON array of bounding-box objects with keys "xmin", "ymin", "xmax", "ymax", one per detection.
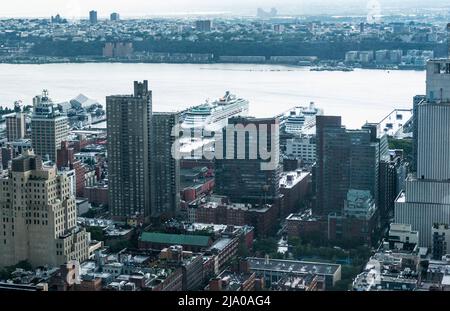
[{"xmin": 151, "ymin": 112, "xmax": 180, "ymax": 217}]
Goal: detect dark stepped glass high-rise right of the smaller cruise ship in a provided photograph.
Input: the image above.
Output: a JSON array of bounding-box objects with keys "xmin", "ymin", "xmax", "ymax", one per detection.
[{"xmin": 314, "ymin": 116, "xmax": 380, "ymax": 216}]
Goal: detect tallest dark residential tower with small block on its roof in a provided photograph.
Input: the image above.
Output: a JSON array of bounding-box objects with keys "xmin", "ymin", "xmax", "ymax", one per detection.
[{"xmin": 106, "ymin": 81, "xmax": 153, "ymax": 219}]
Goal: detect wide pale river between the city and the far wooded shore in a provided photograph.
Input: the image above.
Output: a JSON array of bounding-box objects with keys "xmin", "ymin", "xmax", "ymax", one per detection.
[{"xmin": 0, "ymin": 63, "xmax": 425, "ymax": 128}]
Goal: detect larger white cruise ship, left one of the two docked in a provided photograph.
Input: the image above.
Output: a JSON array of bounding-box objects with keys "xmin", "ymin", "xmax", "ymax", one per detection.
[{"xmin": 181, "ymin": 92, "xmax": 249, "ymax": 132}]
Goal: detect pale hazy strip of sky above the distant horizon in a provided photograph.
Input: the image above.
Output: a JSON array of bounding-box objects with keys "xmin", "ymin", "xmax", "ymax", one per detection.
[{"xmin": 0, "ymin": 0, "xmax": 448, "ymax": 18}]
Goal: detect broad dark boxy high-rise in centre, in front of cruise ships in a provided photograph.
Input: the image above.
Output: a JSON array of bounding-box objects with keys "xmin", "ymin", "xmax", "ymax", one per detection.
[{"xmin": 215, "ymin": 117, "xmax": 282, "ymax": 204}]
